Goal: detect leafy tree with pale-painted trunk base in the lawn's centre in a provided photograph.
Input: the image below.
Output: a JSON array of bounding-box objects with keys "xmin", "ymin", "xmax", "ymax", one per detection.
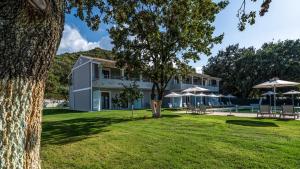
[{"xmin": 110, "ymin": 0, "xmax": 227, "ymax": 117}]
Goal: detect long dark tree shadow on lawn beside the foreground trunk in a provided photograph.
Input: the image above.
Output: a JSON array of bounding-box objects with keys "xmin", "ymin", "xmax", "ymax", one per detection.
[{"xmin": 42, "ymin": 114, "xmax": 180, "ymax": 145}]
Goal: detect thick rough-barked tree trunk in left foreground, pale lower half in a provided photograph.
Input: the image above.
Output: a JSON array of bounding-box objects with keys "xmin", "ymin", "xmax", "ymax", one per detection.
[{"xmin": 0, "ymin": 0, "xmax": 64, "ymax": 169}]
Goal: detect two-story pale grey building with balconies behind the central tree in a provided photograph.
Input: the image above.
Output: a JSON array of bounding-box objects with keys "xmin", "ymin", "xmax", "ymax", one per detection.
[{"xmin": 69, "ymin": 56, "xmax": 221, "ymax": 111}]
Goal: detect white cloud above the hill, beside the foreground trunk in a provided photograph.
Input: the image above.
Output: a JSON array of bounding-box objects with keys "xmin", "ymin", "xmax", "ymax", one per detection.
[{"xmin": 57, "ymin": 25, "xmax": 113, "ymax": 54}]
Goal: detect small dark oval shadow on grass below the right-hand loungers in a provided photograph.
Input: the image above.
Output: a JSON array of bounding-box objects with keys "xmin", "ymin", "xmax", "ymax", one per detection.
[{"xmin": 226, "ymin": 120, "xmax": 278, "ymax": 127}]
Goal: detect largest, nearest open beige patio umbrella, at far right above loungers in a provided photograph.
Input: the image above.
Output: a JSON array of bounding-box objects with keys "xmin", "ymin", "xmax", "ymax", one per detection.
[{"xmin": 253, "ymin": 78, "xmax": 300, "ymax": 109}]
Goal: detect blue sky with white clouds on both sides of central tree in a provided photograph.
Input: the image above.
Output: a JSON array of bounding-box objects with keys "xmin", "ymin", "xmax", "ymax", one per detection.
[{"xmin": 58, "ymin": 0, "xmax": 300, "ymax": 71}]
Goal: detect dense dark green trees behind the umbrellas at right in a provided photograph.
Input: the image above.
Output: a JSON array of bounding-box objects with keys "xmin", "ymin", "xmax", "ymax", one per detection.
[{"xmin": 204, "ymin": 40, "xmax": 300, "ymax": 98}]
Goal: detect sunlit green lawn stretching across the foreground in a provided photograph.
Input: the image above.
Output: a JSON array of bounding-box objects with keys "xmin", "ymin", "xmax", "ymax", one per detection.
[{"xmin": 41, "ymin": 110, "xmax": 300, "ymax": 169}]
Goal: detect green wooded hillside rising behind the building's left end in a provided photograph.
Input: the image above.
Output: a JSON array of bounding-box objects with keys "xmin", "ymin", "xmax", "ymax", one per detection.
[{"xmin": 45, "ymin": 48, "xmax": 113, "ymax": 99}]
